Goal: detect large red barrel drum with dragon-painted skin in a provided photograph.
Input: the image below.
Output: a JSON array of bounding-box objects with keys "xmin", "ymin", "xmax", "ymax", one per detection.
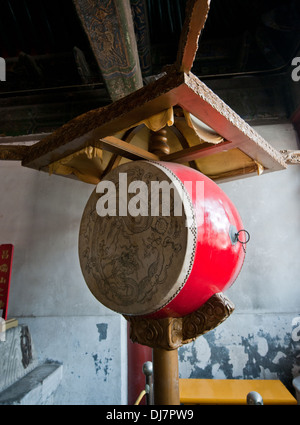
[{"xmin": 79, "ymin": 161, "xmax": 247, "ymax": 318}]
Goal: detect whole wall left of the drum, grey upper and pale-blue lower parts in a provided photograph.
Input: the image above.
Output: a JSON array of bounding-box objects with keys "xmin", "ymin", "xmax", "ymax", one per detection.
[{"xmin": 0, "ymin": 161, "xmax": 127, "ymax": 404}]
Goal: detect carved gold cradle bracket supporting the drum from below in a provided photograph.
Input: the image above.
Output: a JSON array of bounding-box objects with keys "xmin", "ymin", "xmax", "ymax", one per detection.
[{"xmin": 124, "ymin": 292, "xmax": 234, "ymax": 350}]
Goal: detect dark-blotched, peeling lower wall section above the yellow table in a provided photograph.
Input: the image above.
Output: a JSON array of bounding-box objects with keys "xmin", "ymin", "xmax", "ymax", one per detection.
[{"xmin": 179, "ymin": 313, "xmax": 300, "ymax": 393}]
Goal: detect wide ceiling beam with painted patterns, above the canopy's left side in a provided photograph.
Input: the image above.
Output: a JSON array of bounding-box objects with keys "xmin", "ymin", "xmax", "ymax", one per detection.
[{"xmin": 73, "ymin": 0, "xmax": 143, "ymax": 101}]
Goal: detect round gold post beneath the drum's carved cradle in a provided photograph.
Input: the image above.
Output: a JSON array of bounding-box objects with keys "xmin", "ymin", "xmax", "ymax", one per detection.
[{"xmin": 153, "ymin": 348, "xmax": 180, "ymax": 406}]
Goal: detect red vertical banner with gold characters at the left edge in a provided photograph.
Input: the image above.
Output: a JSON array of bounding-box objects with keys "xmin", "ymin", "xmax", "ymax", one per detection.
[{"xmin": 0, "ymin": 244, "xmax": 14, "ymax": 320}]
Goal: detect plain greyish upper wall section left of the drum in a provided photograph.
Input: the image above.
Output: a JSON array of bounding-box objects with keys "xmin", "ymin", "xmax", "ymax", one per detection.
[{"xmin": 0, "ymin": 161, "xmax": 112, "ymax": 316}]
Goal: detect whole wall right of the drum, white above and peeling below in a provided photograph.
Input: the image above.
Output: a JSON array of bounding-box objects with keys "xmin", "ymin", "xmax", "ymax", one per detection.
[{"xmin": 179, "ymin": 124, "xmax": 300, "ymax": 391}]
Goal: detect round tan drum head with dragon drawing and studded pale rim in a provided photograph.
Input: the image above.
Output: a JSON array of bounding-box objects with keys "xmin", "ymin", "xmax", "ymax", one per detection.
[{"xmin": 79, "ymin": 161, "xmax": 197, "ymax": 315}]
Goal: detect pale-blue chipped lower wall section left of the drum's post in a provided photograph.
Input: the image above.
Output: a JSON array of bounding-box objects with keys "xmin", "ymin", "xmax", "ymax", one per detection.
[{"xmin": 22, "ymin": 315, "xmax": 127, "ymax": 405}]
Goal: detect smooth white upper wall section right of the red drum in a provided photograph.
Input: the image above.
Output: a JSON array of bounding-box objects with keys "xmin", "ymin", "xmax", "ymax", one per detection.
[{"xmin": 221, "ymin": 124, "xmax": 300, "ymax": 314}]
